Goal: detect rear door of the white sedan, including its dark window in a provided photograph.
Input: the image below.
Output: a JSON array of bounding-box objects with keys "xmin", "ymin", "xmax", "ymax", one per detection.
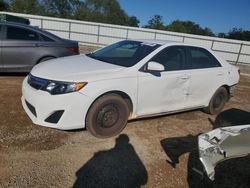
[{"xmin": 186, "ymin": 47, "xmax": 226, "ymax": 107}]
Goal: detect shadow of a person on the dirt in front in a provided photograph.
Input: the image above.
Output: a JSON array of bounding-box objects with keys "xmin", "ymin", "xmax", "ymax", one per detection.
[{"xmin": 73, "ymin": 134, "xmax": 148, "ymax": 188}]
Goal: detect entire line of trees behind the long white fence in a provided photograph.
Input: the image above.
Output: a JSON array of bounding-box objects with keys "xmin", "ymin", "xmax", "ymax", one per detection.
[{"xmin": 0, "ymin": 0, "xmax": 250, "ymax": 41}]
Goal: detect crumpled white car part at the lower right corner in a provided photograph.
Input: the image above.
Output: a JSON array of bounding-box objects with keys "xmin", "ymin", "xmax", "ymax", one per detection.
[{"xmin": 198, "ymin": 125, "xmax": 250, "ymax": 180}]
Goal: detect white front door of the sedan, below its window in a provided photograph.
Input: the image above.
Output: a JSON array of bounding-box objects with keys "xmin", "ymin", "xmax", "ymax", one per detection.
[{"xmin": 137, "ymin": 71, "xmax": 189, "ymax": 116}]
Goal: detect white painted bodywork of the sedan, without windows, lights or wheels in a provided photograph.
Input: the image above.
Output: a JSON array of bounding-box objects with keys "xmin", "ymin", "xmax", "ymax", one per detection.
[{"xmin": 22, "ymin": 40, "xmax": 239, "ymax": 129}]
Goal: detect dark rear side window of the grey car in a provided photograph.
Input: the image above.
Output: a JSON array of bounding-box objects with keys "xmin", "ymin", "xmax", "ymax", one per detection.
[{"xmin": 7, "ymin": 26, "xmax": 39, "ymax": 41}]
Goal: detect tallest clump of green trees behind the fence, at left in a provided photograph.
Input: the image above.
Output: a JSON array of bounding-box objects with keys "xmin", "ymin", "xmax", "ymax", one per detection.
[{"xmin": 3, "ymin": 0, "xmax": 140, "ymax": 27}]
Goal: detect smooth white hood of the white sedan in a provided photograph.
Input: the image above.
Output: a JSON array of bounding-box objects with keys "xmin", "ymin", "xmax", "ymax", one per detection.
[{"xmin": 31, "ymin": 55, "xmax": 125, "ymax": 82}]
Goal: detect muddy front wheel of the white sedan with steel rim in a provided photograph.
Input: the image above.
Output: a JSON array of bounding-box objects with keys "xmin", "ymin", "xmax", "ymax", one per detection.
[{"xmin": 86, "ymin": 94, "xmax": 129, "ymax": 138}]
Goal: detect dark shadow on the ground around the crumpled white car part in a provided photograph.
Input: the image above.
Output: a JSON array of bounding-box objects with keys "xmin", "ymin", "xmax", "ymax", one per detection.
[{"xmin": 161, "ymin": 108, "xmax": 250, "ymax": 188}]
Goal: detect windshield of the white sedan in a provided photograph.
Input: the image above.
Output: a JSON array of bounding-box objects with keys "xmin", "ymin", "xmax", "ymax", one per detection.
[{"xmin": 87, "ymin": 40, "xmax": 160, "ymax": 67}]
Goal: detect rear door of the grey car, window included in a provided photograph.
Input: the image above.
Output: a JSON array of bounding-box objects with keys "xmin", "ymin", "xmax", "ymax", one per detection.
[{"xmin": 2, "ymin": 25, "xmax": 40, "ymax": 71}]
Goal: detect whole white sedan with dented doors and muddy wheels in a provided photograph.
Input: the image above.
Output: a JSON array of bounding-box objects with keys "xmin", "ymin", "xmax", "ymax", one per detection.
[{"xmin": 22, "ymin": 40, "xmax": 239, "ymax": 138}]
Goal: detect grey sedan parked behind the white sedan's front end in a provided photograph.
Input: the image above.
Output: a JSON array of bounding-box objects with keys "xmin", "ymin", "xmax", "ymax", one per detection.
[{"xmin": 0, "ymin": 21, "xmax": 79, "ymax": 72}]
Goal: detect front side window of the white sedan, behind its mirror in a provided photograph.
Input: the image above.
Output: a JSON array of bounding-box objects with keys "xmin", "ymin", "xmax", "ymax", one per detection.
[{"xmin": 151, "ymin": 46, "xmax": 185, "ymax": 71}]
